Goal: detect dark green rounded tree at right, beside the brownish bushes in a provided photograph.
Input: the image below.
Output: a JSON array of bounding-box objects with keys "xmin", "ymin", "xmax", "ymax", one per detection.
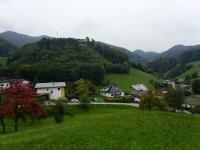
[{"xmin": 164, "ymin": 88, "xmax": 185, "ymax": 111}]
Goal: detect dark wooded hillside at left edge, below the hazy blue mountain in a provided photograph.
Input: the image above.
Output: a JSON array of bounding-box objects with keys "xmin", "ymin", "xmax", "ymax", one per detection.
[{"xmin": 0, "ymin": 38, "xmax": 17, "ymax": 57}]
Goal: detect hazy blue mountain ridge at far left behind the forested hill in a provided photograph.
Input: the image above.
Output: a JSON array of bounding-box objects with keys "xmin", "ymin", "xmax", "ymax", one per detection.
[{"xmin": 0, "ymin": 31, "xmax": 50, "ymax": 48}]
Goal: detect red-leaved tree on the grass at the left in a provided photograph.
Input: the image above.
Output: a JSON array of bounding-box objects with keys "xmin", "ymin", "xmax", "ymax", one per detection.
[{"xmin": 0, "ymin": 81, "xmax": 46, "ymax": 131}]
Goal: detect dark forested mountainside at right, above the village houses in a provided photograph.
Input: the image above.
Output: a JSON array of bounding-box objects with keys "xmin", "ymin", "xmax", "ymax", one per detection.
[{"xmin": 146, "ymin": 48, "xmax": 200, "ymax": 78}]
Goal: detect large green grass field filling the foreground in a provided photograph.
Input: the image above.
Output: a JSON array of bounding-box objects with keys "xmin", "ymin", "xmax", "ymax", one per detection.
[{"xmin": 0, "ymin": 106, "xmax": 200, "ymax": 150}]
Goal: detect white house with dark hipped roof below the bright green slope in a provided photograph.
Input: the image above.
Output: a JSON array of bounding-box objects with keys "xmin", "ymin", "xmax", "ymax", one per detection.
[{"xmin": 100, "ymin": 85, "xmax": 124, "ymax": 97}]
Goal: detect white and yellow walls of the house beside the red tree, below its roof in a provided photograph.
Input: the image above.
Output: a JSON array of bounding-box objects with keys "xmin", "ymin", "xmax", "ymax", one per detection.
[{"xmin": 37, "ymin": 87, "xmax": 65, "ymax": 100}]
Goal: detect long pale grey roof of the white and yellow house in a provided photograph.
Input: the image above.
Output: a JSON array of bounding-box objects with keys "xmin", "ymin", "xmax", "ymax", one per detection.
[{"xmin": 35, "ymin": 82, "xmax": 66, "ymax": 89}]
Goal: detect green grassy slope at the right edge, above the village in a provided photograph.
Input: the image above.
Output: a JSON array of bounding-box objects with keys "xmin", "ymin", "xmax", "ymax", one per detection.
[{"xmin": 179, "ymin": 61, "xmax": 200, "ymax": 78}]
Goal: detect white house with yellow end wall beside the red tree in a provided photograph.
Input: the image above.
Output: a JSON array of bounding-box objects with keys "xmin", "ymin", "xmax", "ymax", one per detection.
[{"xmin": 35, "ymin": 82, "xmax": 66, "ymax": 100}]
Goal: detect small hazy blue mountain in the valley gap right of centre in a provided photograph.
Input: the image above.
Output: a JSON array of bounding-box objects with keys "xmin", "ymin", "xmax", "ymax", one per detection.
[{"xmin": 133, "ymin": 49, "xmax": 160, "ymax": 62}]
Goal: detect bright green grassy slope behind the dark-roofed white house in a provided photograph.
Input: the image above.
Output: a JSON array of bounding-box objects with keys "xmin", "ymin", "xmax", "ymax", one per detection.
[{"xmin": 106, "ymin": 68, "xmax": 158, "ymax": 93}]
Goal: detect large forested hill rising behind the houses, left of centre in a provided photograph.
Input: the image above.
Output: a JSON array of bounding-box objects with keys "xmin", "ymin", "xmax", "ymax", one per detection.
[{"xmin": 0, "ymin": 38, "xmax": 129, "ymax": 83}]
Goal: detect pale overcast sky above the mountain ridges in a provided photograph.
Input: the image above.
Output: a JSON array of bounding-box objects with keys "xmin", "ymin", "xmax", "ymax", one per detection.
[{"xmin": 0, "ymin": 0, "xmax": 200, "ymax": 52}]
